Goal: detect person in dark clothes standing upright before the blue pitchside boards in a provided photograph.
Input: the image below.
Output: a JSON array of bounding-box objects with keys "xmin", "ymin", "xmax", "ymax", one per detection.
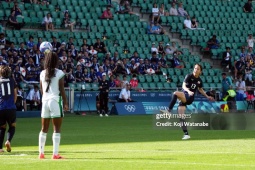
[{"xmin": 99, "ymin": 73, "xmax": 110, "ymax": 117}]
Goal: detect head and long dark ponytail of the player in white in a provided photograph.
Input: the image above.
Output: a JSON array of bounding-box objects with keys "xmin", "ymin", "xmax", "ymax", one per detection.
[{"xmin": 44, "ymin": 52, "xmax": 58, "ymax": 92}]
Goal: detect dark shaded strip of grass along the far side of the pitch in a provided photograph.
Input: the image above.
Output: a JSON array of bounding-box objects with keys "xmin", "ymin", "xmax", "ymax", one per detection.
[{"xmin": 13, "ymin": 115, "xmax": 254, "ymax": 146}]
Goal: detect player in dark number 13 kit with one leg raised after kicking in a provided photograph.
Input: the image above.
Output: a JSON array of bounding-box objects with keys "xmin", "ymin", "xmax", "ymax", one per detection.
[{"xmin": 160, "ymin": 64, "xmax": 214, "ymax": 140}]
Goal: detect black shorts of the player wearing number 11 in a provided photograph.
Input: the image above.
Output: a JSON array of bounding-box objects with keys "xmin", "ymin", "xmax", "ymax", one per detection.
[{"xmin": 0, "ymin": 109, "xmax": 16, "ymax": 126}]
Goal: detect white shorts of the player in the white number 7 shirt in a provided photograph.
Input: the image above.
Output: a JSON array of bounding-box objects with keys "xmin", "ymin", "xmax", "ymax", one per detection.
[{"xmin": 41, "ymin": 99, "xmax": 64, "ymax": 118}]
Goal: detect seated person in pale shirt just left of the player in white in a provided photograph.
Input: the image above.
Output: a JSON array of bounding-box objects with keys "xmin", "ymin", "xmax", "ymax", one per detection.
[{"xmin": 26, "ymin": 85, "xmax": 41, "ymax": 110}]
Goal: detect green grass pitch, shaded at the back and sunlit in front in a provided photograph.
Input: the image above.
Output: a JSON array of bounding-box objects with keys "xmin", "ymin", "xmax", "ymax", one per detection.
[{"xmin": 0, "ymin": 115, "xmax": 255, "ymax": 170}]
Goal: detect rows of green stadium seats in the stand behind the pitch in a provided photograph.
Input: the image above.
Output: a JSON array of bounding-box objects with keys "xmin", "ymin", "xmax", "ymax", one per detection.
[{"xmin": 0, "ymin": 0, "xmax": 254, "ymax": 95}]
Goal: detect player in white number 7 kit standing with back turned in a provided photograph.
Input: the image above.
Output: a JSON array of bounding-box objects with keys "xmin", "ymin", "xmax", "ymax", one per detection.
[{"xmin": 39, "ymin": 52, "xmax": 68, "ymax": 159}]
